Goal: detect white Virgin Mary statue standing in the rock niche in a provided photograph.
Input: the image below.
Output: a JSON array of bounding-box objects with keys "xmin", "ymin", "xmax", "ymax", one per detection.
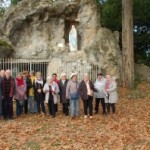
[{"xmin": 69, "ymin": 25, "xmax": 77, "ymax": 52}]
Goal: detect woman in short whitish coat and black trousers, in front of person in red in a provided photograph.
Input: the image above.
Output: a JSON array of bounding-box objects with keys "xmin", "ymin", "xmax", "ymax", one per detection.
[{"xmin": 43, "ymin": 77, "xmax": 59, "ymax": 118}]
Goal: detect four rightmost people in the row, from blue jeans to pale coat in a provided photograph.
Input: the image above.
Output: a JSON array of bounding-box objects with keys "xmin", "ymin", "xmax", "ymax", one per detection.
[{"xmin": 66, "ymin": 73, "xmax": 118, "ymax": 118}]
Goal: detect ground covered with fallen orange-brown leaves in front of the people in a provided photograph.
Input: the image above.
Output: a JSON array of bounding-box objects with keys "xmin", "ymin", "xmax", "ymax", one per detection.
[{"xmin": 0, "ymin": 84, "xmax": 150, "ymax": 150}]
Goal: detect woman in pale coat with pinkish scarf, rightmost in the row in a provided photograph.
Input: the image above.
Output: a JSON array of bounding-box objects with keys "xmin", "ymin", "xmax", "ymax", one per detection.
[{"xmin": 105, "ymin": 75, "xmax": 118, "ymax": 114}]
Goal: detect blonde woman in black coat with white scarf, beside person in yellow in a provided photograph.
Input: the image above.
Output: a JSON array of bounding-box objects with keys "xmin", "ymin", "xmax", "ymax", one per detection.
[{"xmin": 33, "ymin": 72, "xmax": 45, "ymax": 115}]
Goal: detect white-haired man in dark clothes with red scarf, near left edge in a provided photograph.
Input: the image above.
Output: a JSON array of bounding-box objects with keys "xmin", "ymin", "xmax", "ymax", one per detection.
[{"xmin": 2, "ymin": 70, "xmax": 16, "ymax": 119}]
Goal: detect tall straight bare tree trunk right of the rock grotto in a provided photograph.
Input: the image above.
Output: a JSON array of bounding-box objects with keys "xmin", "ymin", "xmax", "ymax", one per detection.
[{"xmin": 122, "ymin": 0, "xmax": 134, "ymax": 89}]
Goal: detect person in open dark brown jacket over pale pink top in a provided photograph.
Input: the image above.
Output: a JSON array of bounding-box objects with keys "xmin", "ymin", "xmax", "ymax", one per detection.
[{"xmin": 79, "ymin": 74, "xmax": 97, "ymax": 118}]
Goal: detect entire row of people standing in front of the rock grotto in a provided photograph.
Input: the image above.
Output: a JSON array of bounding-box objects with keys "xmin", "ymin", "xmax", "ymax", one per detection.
[{"xmin": 0, "ymin": 70, "xmax": 118, "ymax": 119}]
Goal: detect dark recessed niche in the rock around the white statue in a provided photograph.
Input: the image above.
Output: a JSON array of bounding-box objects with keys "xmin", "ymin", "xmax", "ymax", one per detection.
[{"xmin": 64, "ymin": 19, "xmax": 81, "ymax": 50}]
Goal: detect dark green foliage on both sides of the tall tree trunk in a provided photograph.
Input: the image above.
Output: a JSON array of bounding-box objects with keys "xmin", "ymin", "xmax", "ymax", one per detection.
[{"xmin": 101, "ymin": 0, "xmax": 150, "ymax": 65}]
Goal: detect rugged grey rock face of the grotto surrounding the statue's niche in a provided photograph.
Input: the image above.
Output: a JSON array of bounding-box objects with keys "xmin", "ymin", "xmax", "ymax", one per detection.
[{"xmin": 0, "ymin": 0, "xmax": 121, "ymax": 77}]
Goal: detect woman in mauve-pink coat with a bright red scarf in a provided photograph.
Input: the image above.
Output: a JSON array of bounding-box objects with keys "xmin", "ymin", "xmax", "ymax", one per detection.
[{"xmin": 14, "ymin": 73, "xmax": 27, "ymax": 117}]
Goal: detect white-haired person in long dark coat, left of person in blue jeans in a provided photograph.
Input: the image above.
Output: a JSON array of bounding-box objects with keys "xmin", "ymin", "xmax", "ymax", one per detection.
[{"xmin": 58, "ymin": 73, "xmax": 69, "ymax": 116}]
